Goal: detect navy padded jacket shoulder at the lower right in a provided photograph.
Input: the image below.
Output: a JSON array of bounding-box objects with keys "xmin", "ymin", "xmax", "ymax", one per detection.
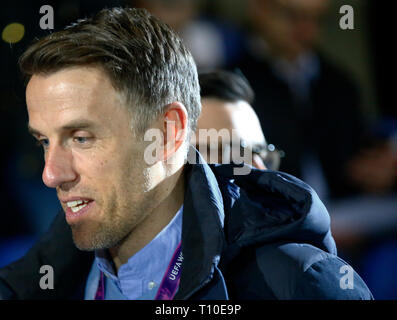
[{"xmin": 256, "ymin": 243, "xmax": 373, "ymax": 300}]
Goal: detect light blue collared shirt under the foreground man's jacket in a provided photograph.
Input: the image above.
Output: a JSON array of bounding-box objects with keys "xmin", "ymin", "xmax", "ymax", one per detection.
[{"xmin": 85, "ymin": 205, "xmax": 183, "ymax": 300}]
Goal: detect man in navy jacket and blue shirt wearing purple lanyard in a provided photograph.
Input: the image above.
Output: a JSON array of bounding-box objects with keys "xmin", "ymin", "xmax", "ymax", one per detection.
[{"xmin": 0, "ymin": 8, "xmax": 372, "ymax": 300}]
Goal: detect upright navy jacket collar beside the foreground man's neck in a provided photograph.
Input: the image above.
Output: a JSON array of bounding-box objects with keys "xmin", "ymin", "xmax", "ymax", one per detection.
[{"xmin": 175, "ymin": 149, "xmax": 224, "ymax": 299}]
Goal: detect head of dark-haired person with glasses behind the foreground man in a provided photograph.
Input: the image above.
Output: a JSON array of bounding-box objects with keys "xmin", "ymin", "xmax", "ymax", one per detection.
[{"xmin": 195, "ymin": 70, "xmax": 280, "ymax": 170}]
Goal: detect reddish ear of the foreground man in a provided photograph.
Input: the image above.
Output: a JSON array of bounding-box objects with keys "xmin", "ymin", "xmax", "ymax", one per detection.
[{"xmin": 162, "ymin": 102, "xmax": 188, "ymax": 161}]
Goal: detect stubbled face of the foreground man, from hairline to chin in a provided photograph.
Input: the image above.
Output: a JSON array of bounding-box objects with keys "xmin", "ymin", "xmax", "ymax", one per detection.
[{"xmin": 26, "ymin": 67, "xmax": 154, "ymax": 250}]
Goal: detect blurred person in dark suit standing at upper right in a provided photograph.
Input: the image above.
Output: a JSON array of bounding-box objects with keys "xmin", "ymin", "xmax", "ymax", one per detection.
[{"xmin": 232, "ymin": 0, "xmax": 397, "ymax": 200}]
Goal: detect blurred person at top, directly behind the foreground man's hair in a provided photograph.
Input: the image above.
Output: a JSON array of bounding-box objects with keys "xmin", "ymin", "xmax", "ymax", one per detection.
[{"xmin": 131, "ymin": 0, "xmax": 243, "ymax": 70}]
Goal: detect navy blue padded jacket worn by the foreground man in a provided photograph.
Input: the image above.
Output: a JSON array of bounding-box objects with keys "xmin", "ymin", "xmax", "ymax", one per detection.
[{"xmin": 0, "ymin": 154, "xmax": 373, "ymax": 300}]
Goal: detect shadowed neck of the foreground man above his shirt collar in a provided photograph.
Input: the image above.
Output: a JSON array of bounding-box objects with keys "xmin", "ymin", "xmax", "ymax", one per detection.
[{"xmin": 109, "ymin": 167, "xmax": 185, "ymax": 271}]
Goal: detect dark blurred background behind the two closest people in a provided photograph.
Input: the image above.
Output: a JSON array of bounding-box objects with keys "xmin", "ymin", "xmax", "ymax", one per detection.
[{"xmin": 0, "ymin": 0, "xmax": 397, "ymax": 299}]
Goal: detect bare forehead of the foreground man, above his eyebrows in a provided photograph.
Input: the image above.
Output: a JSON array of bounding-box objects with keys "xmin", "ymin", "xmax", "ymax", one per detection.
[{"xmin": 26, "ymin": 67, "xmax": 125, "ymax": 130}]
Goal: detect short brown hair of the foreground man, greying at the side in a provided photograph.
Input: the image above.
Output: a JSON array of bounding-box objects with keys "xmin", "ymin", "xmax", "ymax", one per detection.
[{"xmin": 19, "ymin": 8, "xmax": 201, "ymax": 136}]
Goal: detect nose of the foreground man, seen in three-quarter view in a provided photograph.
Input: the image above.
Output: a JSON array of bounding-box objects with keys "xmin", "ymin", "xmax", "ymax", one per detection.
[{"xmin": 42, "ymin": 146, "xmax": 77, "ymax": 188}]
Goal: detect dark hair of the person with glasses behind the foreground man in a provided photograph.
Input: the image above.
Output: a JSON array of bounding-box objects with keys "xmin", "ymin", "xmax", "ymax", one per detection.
[{"xmin": 199, "ymin": 70, "xmax": 255, "ymax": 104}]
